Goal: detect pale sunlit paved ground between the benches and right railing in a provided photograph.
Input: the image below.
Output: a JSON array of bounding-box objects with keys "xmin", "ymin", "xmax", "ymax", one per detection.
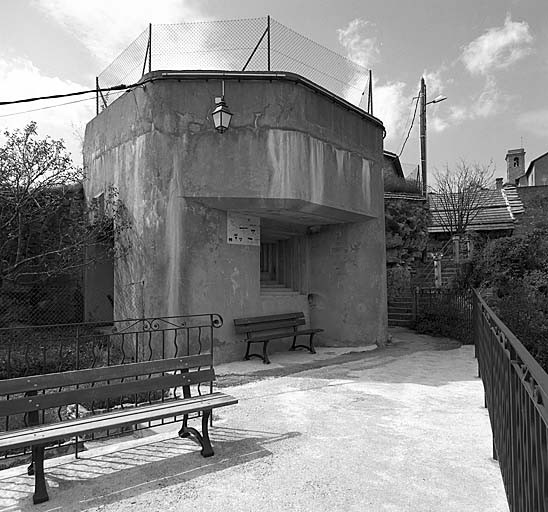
[{"xmin": 0, "ymin": 329, "xmax": 508, "ymax": 512}]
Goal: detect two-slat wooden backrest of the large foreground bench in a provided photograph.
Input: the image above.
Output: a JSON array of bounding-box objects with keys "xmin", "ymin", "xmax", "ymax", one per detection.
[{"xmin": 0, "ymin": 353, "xmax": 215, "ymax": 416}]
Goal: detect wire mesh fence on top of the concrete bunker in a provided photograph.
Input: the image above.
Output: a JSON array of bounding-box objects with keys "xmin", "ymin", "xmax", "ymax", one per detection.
[{"xmin": 98, "ymin": 17, "xmax": 369, "ymax": 107}]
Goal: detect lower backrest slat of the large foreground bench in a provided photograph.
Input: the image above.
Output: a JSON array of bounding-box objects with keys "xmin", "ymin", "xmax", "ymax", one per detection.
[{"xmin": 0, "ymin": 368, "xmax": 215, "ymax": 416}]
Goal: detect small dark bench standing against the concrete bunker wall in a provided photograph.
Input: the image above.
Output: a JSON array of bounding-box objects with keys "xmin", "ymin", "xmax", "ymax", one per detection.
[{"xmin": 234, "ymin": 312, "xmax": 323, "ymax": 364}]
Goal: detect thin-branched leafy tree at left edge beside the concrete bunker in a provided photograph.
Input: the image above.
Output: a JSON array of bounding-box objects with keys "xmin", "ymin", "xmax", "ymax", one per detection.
[{"xmin": 0, "ymin": 122, "xmax": 129, "ymax": 285}]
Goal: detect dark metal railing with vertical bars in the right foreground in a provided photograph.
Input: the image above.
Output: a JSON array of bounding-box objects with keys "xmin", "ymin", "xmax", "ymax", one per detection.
[{"xmin": 473, "ymin": 291, "xmax": 548, "ymax": 512}]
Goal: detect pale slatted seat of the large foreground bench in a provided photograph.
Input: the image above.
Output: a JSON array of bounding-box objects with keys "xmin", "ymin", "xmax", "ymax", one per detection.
[{"xmin": 0, "ymin": 392, "xmax": 238, "ymax": 449}]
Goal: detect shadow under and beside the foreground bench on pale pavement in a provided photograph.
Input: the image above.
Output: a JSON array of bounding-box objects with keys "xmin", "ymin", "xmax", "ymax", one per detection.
[{"xmin": 0, "ymin": 427, "xmax": 301, "ymax": 512}]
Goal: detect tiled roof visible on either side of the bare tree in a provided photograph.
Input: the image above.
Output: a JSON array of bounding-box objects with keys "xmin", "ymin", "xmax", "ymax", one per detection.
[{"xmin": 428, "ymin": 186, "xmax": 524, "ymax": 233}]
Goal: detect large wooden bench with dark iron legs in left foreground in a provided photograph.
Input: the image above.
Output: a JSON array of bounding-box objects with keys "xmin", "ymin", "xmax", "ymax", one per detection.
[{"xmin": 0, "ymin": 353, "xmax": 238, "ymax": 503}]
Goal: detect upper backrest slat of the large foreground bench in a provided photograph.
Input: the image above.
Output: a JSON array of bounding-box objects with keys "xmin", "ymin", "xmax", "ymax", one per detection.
[{"xmin": 0, "ymin": 352, "xmax": 213, "ymax": 395}]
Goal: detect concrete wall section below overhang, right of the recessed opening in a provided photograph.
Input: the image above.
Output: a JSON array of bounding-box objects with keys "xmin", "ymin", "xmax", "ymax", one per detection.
[{"xmin": 310, "ymin": 218, "xmax": 388, "ymax": 346}]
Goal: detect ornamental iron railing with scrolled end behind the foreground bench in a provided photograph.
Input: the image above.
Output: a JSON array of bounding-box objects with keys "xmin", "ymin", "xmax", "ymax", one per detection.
[{"xmin": 0, "ymin": 313, "xmax": 223, "ymax": 468}]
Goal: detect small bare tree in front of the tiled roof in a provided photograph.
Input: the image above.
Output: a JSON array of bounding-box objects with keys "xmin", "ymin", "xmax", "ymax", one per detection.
[{"xmin": 430, "ymin": 160, "xmax": 495, "ymax": 235}]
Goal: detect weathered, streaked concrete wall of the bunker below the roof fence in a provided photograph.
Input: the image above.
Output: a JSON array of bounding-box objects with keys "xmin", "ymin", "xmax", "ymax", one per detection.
[{"xmin": 84, "ymin": 72, "xmax": 386, "ymax": 361}]
